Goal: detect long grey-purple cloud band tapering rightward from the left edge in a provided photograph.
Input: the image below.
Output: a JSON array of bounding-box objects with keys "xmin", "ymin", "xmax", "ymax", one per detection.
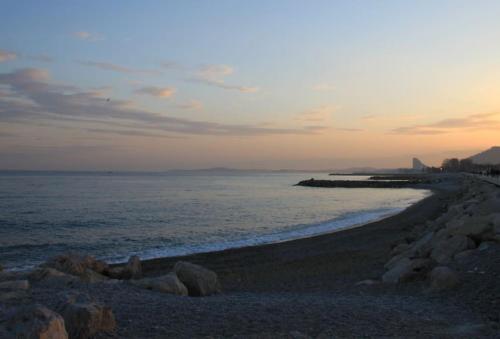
[{"xmin": 0, "ymin": 69, "xmax": 321, "ymax": 136}]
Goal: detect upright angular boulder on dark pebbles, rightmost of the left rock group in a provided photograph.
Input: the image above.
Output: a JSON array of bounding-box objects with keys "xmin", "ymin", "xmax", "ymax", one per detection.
[{"xmin": 174, "ymin": 261, "xmax": 220, "ymax": 296}]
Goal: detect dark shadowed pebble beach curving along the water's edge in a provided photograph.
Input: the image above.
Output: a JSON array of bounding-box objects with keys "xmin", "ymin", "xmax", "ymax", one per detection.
[{"xmin": 0, "ymin": 176, "xmax": 500, "ymax": 338}]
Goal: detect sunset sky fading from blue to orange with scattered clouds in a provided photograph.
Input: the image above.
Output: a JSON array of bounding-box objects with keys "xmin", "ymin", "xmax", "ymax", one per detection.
[{"xmin": 0, "ymin": 0, "xmax": 500, "ymax": 171}]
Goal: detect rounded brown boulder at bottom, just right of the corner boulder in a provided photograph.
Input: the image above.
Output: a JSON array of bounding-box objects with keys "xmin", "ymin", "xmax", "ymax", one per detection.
[{"xmin": 60, "ymin": 296, "xmax": 116, "ymax": 339}]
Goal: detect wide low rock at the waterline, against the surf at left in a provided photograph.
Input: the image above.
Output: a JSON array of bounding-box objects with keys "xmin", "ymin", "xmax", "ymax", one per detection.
[{"xmin": 42, "ymin": 253, "xmax": 109, "ymax": 276}]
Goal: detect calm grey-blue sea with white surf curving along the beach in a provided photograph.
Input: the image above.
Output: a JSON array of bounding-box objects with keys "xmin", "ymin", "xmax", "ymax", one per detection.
[{"xmin": 0, "ymin": 171, "xmax": 429, "ymax": 269}]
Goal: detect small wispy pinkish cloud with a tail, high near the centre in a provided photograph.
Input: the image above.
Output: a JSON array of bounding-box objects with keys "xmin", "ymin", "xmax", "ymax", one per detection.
[{"xmin": 190, "ymin": 65, "xmax": 259, "ymax": 93}]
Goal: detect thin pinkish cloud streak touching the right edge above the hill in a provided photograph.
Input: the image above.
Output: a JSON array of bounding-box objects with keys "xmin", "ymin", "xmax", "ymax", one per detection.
[{"xmin": 391, "ymin": 113, "xmax": 500, "ymax": 135}]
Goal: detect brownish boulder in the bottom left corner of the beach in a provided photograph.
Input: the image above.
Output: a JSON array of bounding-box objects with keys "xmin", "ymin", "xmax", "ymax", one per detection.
[{"xmin": 5, "ymin": 305, "xmax": 68, "ymax": 339}]
